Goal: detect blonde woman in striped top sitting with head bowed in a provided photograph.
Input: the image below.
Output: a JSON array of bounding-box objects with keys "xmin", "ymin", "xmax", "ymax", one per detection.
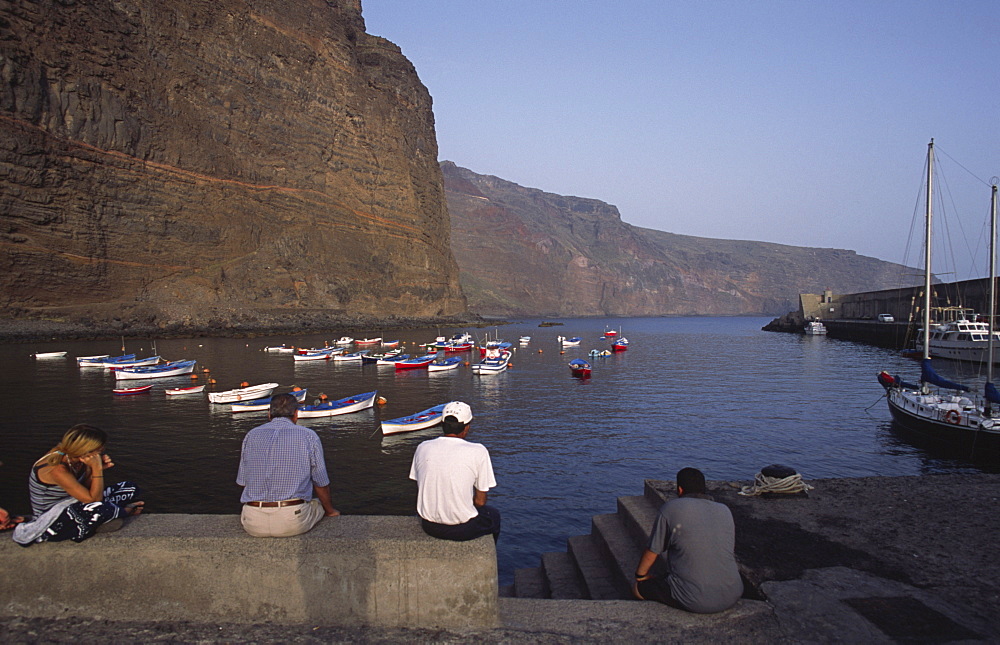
[{"xmin": 14, "ymin": 424, "xmax": 143, "ymax": 546}]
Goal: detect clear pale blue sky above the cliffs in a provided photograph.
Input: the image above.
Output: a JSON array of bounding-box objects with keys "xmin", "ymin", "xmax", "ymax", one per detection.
[{"xmin": 363, "ymin": 0, "xmax": 1000, "ymax": 278}]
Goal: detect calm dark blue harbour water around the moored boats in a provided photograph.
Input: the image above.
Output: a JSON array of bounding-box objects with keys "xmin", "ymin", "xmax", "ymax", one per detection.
[{"xmin": 0, "ymin": 317, "xmax": 996, "ymax": 582}]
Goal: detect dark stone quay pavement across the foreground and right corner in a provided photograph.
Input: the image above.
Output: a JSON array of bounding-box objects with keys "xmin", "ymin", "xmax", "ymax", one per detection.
[{"xmin": 0, "ymin": 474, "xmax": 1000, "ymax": 643}]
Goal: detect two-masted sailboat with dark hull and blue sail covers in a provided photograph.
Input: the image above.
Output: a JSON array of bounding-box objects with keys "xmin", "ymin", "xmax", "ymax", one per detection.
[{"xmin": 878, "ymin": 139, "xmax": 1000, "ymax": 450}]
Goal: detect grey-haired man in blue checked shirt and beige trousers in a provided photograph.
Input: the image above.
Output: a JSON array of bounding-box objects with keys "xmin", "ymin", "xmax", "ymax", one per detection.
[{"xmin": 236, "ymin": 394, "xmax": 340, "ymax": 537}]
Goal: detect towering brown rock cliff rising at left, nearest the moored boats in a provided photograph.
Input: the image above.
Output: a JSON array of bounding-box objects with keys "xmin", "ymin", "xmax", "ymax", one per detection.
[{"xmin": 0, "ymin": 0, "xmax": 465, "ymax": 324}]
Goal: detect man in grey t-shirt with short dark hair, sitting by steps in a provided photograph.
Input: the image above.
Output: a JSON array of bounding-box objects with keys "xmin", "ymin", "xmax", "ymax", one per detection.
[{"xmin": 632, "ymin": 468, "xmax": 743, "ymax": 614}]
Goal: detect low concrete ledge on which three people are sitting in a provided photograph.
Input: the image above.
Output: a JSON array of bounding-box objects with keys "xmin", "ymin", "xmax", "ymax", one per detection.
[{"xmin": 0, "ymin": 515, "xmax": 498, "ymax": 629}]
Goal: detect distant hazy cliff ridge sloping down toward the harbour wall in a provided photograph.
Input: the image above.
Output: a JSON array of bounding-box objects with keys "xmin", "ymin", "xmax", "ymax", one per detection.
[{"xmin": 442, "ymin": 162, "xmax": 920, "ymax": 316}]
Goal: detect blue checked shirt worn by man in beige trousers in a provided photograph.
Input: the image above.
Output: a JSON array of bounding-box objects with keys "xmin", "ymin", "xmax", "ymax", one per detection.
[{"xmin": 236, "ymin": 417, "xmax": 330, "ymax": 502}]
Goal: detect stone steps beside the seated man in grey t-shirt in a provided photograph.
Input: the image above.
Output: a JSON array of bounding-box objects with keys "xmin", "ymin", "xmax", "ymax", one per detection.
[{"xmin": 500, "ymin": 481, "xmax": 666, "ymax": 600}]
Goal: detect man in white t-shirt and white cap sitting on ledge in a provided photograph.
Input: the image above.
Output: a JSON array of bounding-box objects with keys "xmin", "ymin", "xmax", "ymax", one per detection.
[{"xmin": 410, "ymin": 401, "xmax": 500, "ymax": 541}]
